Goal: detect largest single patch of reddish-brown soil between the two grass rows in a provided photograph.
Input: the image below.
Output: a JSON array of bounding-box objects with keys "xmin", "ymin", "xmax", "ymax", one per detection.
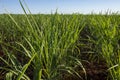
[{"xmin": 83, "ymin": 62, "xmax": 107, "ymax": 80}]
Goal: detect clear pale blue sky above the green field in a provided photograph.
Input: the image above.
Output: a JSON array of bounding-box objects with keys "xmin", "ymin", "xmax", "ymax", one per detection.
[{"xmin": 0, "ymin": 0, "xmax": 120, "ymax": 14}]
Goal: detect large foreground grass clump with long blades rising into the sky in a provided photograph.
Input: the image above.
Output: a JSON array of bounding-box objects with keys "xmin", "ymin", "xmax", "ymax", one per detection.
[{"xmin": 1, "ymin": 0, "xmax": 85, "ymax": 80}]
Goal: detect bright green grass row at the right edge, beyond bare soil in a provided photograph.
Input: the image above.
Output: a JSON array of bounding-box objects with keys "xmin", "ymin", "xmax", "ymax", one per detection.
[{"xmin": 87, "ymin": 14, "xmax": 120, "ymax": 80}]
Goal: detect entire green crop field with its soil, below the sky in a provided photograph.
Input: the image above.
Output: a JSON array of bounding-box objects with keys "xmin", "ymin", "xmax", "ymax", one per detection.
[{"xmin": 0, "ymin": 13, "xmax": 120, "ymax": 80}]
